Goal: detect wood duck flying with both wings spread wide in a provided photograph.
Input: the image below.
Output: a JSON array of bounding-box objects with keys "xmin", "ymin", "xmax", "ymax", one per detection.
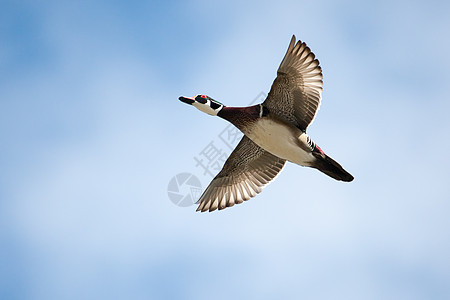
[{"xmin": 179, "ymin": 35, "xmax": 353, "ymax": 212}]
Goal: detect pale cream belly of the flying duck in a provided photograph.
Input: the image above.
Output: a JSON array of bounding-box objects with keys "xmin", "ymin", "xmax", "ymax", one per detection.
[{"xmin": 244, "ymin": 118, "xmax": 314, "ymax": 166}]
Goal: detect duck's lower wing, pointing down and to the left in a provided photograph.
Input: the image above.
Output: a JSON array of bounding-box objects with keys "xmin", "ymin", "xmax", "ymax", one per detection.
[{"xmin": 197, "ymin": 136, "xmax": 286, "ymax": 212}]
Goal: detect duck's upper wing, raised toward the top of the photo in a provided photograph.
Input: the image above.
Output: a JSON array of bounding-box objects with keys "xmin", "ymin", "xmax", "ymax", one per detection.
[{"xmin": 263, "ymin": 35, "xmax": 323, "ymax": 130}]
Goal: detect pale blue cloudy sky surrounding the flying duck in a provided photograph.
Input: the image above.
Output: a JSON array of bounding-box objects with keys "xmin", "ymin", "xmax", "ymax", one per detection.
[{"xmin": 0, "ymin": 1, "xmax": 450, "ymax": 299}]
